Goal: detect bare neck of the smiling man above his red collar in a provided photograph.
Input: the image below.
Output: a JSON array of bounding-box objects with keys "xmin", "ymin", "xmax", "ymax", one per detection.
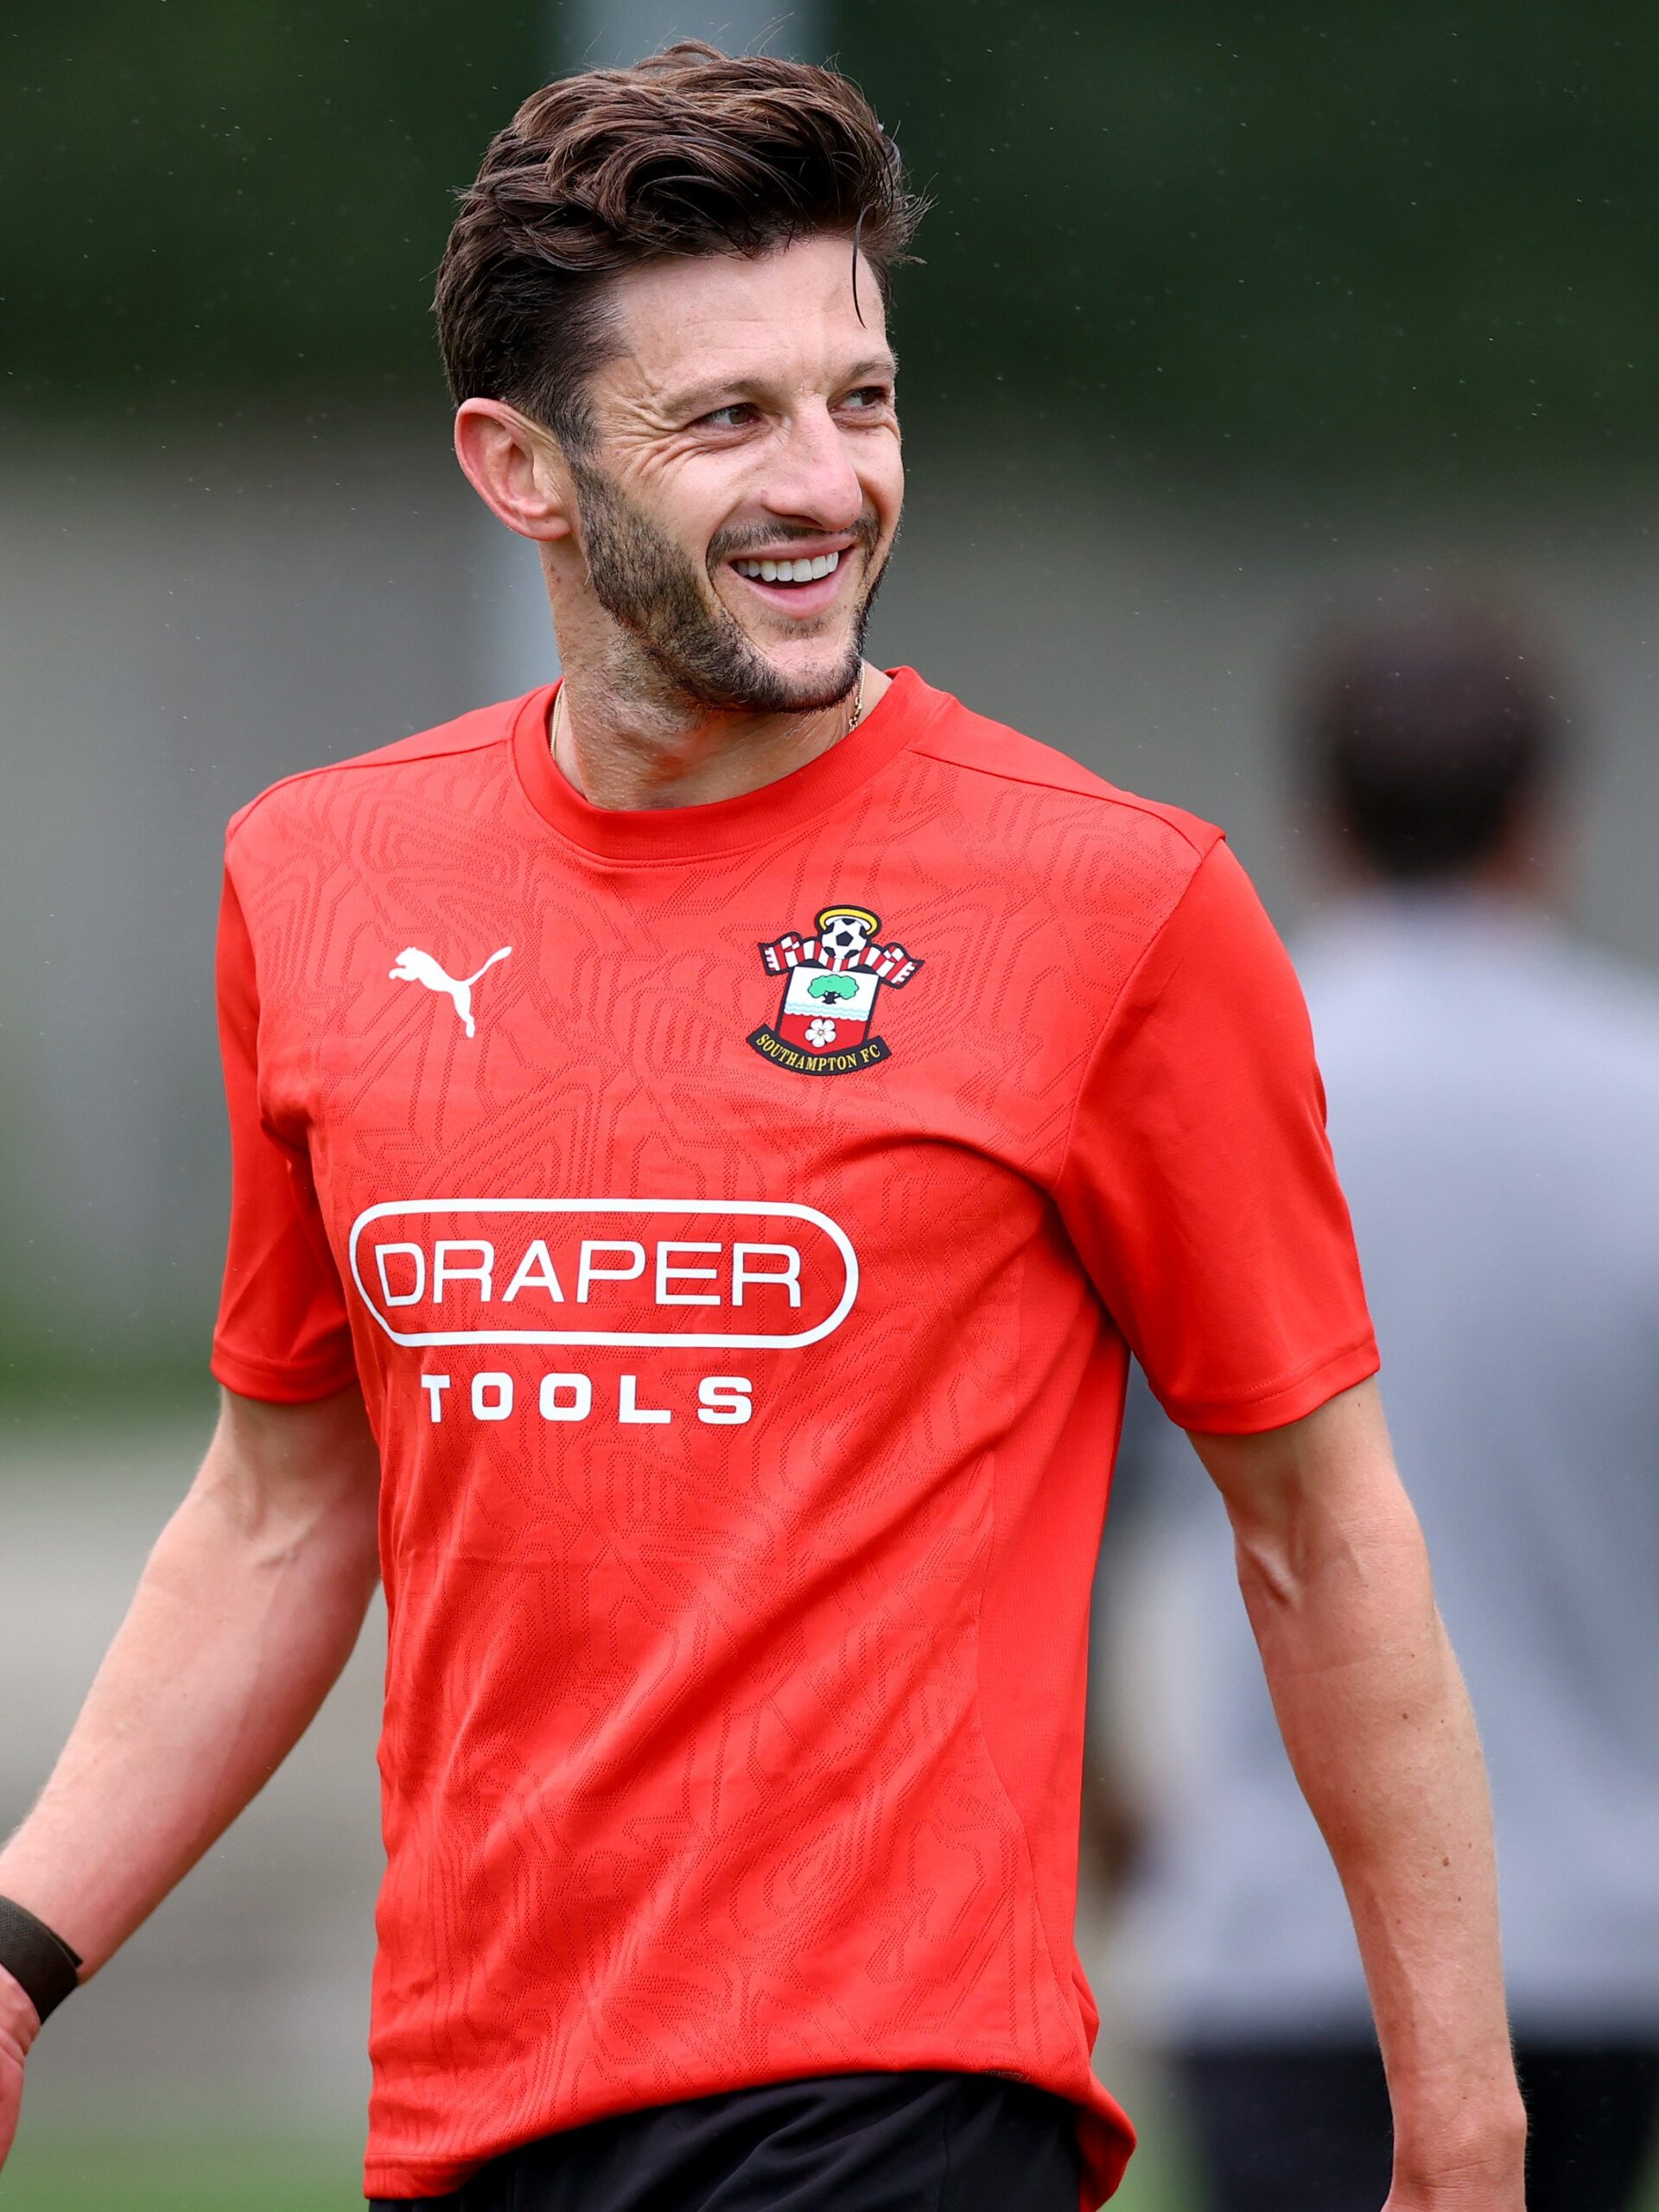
[{"xmin": 553, "ymin": 664, "xmax": 889, "ymax": 810}]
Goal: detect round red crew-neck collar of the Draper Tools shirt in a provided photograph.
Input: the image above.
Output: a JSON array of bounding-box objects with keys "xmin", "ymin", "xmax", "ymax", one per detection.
[{"xmin": 511, "ymin": 668, "xmax": 944, "ymax": 861}]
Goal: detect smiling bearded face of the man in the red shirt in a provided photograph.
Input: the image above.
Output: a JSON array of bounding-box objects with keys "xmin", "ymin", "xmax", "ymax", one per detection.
[{"xmin": 570, "ymin": 238, "xmax": 905, "ymax": 712}]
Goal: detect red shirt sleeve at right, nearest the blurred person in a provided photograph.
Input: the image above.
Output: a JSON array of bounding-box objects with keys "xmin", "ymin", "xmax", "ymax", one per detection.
[{"xmin": 1055, "ymin": 845, "xmax": 1378, "ymax": 1433}]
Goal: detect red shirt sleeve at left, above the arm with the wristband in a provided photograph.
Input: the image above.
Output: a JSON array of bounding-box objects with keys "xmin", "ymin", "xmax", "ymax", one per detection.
[{"xmin": 213, "ymin": 876, "xmax": 356, "ymax": 1405}]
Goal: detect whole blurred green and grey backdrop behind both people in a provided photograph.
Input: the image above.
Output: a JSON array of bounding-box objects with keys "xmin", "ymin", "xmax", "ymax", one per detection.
[{"xmin": 0, "ymin": 0, "xmax": 1659, "ymax": 2212}]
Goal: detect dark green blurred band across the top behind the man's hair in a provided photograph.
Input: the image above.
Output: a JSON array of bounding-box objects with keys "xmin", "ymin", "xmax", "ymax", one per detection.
[{"xmin": 13, "ymin": 0, "xmax": 1659, "ymax": 491}]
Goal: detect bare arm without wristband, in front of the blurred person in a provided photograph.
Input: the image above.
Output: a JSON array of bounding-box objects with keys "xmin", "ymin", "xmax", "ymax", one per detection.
[{"xmin": 1192, "ymin": 1382, "xmax": 1526, "ymax": 2212}]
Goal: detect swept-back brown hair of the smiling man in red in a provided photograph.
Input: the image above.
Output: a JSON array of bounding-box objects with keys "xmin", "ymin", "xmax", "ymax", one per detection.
[{"xmin": 434, "ymin": 40, "xmax": 925, "ymax": 447}]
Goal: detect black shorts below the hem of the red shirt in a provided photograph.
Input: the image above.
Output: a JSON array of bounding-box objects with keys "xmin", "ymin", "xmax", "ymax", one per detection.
[{"xmin": 374, "ymin": 2073, "xmax": 1077, "ymax": 2212}]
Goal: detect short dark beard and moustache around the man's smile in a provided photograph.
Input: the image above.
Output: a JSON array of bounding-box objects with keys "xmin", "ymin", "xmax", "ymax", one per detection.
[{"xmin": 570, "ymin": 460, "xmax": 887, "ymax": 715}]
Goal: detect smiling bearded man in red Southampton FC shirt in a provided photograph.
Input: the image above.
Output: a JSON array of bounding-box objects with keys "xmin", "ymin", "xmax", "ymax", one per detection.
[{"xmin": 0, "ymin": 47, "xmax": 1520, "ymax": 2212}]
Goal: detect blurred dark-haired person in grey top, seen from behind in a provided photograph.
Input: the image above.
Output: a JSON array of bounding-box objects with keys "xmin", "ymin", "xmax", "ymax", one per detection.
[{"xmin": 1110, "ymin": 611, "xmax": 1659, "ymax": 2212}]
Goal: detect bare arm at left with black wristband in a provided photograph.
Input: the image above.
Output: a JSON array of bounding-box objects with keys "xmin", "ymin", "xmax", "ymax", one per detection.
[{"xmin": 0, "ymin": 1389, "xmax": 380, "ymax": 2164}]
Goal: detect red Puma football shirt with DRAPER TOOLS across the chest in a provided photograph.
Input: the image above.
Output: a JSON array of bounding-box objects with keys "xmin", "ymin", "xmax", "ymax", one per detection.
[{"xmin": 214, "ymin": 671, "xmax": 1376, "ymax": 2203}]
